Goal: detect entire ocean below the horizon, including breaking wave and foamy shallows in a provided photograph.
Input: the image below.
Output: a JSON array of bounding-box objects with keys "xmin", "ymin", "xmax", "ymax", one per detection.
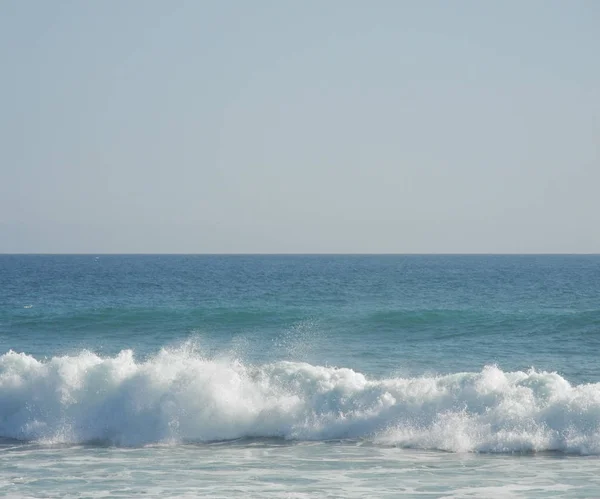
[{"xmin": 0, "ymin": 255, "xmax": 600, "ymax": 498}]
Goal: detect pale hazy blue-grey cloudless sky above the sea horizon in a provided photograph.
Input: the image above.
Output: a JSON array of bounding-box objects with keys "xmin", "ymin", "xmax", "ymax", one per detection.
[{"xmin": 0, "ymin": 0, "xmax": 600, "ymax": 253}]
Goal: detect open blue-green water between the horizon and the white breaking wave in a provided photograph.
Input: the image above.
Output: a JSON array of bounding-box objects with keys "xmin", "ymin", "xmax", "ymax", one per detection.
[{"xmin": 0, "ymin": 255, "xmax": 600, "ymax": 383}]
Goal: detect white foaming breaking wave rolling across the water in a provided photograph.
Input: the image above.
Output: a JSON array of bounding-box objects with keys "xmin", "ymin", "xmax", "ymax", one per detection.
[{"xmin": 0, "ymin": 346, "xmax": 600, "ymax": 454}]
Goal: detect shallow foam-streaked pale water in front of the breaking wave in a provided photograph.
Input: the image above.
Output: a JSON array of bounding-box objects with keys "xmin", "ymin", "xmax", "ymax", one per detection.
[{"xmin": 0, "ymin": 439, "xmax": 600, "ymax": 498}]
